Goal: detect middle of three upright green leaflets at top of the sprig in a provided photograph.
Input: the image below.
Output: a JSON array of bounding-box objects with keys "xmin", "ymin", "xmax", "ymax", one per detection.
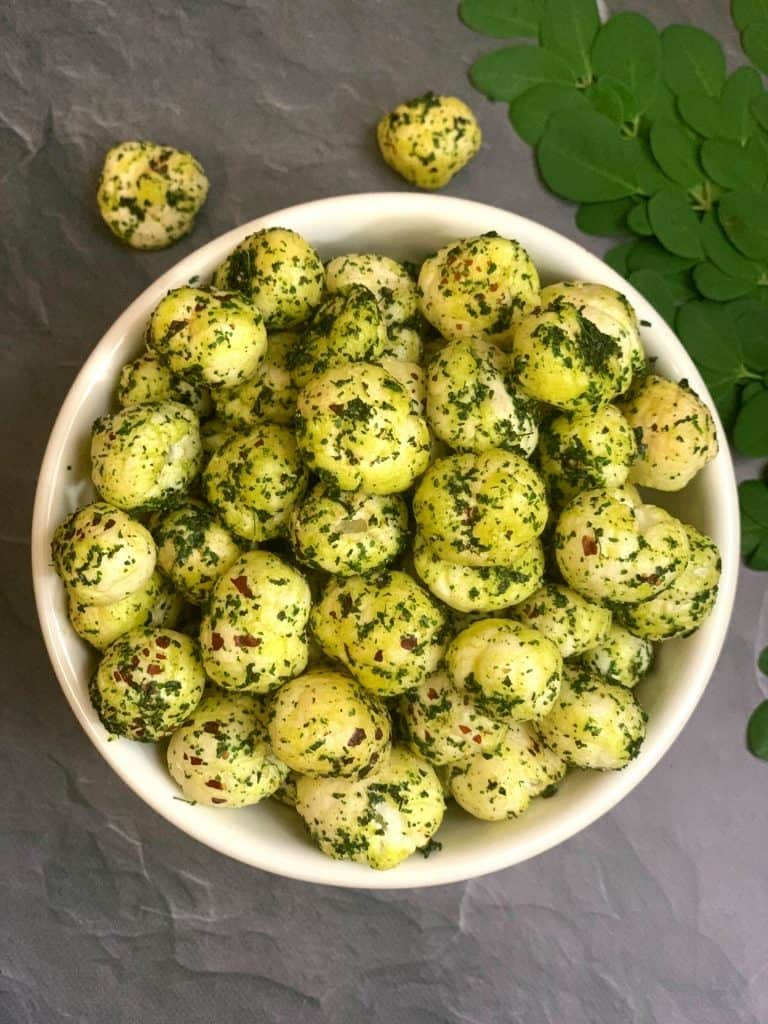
[{"xmin": 592, "ymin": 12, "xmax": 662, "ymax": 117}]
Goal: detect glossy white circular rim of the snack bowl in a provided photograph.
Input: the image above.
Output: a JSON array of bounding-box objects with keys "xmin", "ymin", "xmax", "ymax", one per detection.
[{"xmin": 31, "ymin": 191, "xmax": 739, "ymax": 890}]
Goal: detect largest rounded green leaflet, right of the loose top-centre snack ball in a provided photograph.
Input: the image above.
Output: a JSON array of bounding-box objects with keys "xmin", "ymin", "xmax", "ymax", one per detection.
[{"xmin": 537, "ymin": 110, "xmax": 641, "ymax": 203}]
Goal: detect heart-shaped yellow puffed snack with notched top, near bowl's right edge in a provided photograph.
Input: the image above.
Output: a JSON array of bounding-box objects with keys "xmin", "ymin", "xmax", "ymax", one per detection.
[{"xmin": 554, "ymin": 487, "xmax": 689, "ymax": 604}]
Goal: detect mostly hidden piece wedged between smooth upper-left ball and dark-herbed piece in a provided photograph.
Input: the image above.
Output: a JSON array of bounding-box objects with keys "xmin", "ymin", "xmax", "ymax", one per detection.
[{"xmin": 213, "ymin": 331, "xmax": 298, "ymax": 430}]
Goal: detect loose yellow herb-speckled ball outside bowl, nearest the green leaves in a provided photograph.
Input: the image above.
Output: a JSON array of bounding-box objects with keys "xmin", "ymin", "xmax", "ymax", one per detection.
[{"xmin": 376, "ymin": 92, "xmax": 482, "ymax": 188}]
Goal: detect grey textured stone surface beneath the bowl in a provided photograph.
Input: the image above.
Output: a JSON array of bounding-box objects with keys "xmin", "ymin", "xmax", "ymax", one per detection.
[{"xmin": 0, "ymin": 0, "xmax": 768, "ymax": 1024}]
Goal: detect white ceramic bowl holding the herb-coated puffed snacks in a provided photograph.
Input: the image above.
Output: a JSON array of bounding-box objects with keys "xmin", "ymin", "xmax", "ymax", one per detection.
[{"xmin": 32, "ymin": 193, "xmax": 738, "ymax": 889}]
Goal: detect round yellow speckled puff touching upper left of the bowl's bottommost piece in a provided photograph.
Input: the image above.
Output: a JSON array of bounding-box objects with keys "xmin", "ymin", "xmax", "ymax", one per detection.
[{"xmin": 269, "ymin": 670, "xmax": 391, "ymax": 778}]
